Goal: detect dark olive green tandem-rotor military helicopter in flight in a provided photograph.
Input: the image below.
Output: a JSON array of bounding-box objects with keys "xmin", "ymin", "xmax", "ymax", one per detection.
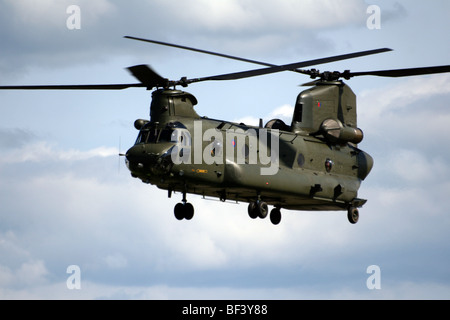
[{"xmin": 0, "ymin": 36, "xmax": 450, "ymax": 224}]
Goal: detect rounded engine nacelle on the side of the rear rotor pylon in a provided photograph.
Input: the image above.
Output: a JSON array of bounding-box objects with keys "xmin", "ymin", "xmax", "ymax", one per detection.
[{"xmin": 320, "ymin": 119, "xmax": 364, "ymax": 144}]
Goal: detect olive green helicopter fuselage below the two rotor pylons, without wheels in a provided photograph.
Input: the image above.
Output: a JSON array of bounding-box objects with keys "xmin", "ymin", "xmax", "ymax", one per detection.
[{"xmin": 127, "ymin": 90, "xmax": 372, "ymax": 210}]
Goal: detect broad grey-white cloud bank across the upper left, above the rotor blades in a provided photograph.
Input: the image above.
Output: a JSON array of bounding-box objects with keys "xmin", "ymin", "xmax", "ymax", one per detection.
[{"xmin": 0, "ymin": 0, "xmax": 372, "ymax": 80}]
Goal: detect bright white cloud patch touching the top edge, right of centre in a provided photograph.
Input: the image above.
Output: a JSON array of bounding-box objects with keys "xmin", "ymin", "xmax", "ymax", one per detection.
[{"xmin": 165, "ymin": 0, "xmax": 366, "ymax": 32}]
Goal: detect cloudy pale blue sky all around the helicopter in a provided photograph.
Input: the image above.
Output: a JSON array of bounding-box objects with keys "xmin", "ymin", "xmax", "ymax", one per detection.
[{"xmin": 0, "ymin": 0, "xmax": 450, "ymax": 300}]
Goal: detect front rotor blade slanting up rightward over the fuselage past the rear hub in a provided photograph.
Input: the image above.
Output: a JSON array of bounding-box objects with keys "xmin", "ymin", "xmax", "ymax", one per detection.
[{"xmin": 187, "ymin": 48, "xmax": 392, "ymax": 83}]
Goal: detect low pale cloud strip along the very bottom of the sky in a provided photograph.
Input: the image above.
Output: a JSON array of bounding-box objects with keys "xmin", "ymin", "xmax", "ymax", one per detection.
[{"xmin": 0, "ymin": 280, "xmax": 450, "ymax": 300}]
